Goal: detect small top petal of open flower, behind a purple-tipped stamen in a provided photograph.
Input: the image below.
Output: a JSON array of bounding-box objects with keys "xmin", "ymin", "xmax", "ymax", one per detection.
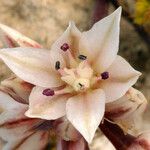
[{"xmin": 51, "ymin": 21, "xmax": 81, "ymax": 66}]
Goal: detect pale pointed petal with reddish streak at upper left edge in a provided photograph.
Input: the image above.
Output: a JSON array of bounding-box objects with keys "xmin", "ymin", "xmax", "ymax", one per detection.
[{"xmin": 0, "ymin": 24, "xmax": 42, "ymax": 48}]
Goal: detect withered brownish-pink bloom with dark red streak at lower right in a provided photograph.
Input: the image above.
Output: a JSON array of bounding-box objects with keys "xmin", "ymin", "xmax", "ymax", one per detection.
[{"xmin": 105, "ymin": 88, "xmax": 147, "ymax": 132}]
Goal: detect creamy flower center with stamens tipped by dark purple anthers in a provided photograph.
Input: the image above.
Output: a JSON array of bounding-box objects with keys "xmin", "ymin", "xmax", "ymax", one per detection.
[{"xmin": 43, "ymin": 43, "xmax": 109, "ymax": 96}]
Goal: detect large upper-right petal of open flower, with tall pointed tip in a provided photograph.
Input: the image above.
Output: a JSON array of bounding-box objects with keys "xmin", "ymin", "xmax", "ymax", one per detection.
[{"xmin": 79, "ymin": 7, "xmax": 121, "ymax": 73}]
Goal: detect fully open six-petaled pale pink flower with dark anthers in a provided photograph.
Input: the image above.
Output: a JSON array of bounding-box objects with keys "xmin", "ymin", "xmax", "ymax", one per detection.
[{"xmin": 0, "ymin": 8, "xmax": 140, "ymax": 143}]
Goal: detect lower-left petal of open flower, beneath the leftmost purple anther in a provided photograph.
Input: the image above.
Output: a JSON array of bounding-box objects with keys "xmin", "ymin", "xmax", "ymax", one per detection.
[{"xmin": 25, "ymin": 87, "xmax": 69, "ymax": 120}]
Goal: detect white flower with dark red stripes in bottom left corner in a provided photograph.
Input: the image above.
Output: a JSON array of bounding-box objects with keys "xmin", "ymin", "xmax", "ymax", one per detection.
[{"xmin": 0, "ymin": 86, "xmax": 49, "ymax": 150}]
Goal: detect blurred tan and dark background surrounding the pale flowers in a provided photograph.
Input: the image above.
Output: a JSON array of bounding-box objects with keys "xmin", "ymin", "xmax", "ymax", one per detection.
[{"xmin": 0, "ymin": 0, "xmax": 150, "ymax": 150}]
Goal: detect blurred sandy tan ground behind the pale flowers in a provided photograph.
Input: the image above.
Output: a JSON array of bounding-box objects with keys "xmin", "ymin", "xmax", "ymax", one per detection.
[{"xmin": 0, "ymin": 0, "xmax": 150, "ymax": 150}]
